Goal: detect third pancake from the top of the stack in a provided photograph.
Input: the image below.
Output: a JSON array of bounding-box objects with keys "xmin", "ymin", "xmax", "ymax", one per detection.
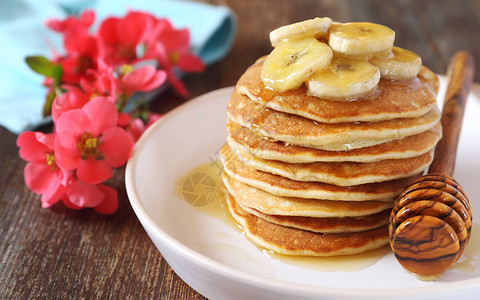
[{"xmin": 227, "ymin": 120, "xmax": 442, "ymax": 163}]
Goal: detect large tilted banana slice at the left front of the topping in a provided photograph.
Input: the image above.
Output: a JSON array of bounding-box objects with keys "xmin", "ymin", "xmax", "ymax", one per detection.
[{"xmin": 261, "ymin": 37, "xmax": 333, "ymax": 92}]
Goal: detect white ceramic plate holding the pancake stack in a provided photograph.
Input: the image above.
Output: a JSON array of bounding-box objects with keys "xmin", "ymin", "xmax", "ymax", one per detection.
[{"xmin": 125, "ymin": 77, "xmax": 480, "ymax": 299}]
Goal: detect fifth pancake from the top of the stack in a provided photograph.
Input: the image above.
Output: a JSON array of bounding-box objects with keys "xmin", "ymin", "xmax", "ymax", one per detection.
[{"xmin": 220, "ymin": 148, "xmax": 420, "ymax": 201}]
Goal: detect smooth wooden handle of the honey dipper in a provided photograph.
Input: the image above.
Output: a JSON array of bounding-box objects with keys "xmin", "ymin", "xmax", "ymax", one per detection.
[{"xmin": 428, "ymin": 51, "xmax": 475, "ymax": 176}]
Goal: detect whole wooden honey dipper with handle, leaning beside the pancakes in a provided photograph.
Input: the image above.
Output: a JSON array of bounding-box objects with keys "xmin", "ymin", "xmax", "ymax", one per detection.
[{"xmin": 388, "ymin": 51, "xmax": 475, "ymax": 280}]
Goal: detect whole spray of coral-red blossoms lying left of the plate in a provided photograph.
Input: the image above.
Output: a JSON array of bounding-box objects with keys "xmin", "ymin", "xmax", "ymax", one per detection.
[{"xmin": 21, "ymin": 10, "xmax": 204, "ymax": 214}]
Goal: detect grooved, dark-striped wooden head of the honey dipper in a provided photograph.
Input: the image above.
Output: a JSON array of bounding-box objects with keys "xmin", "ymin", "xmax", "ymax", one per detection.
[{"xmin": 389, "ymin": 174, "xmax": 472, "ymax": 276}]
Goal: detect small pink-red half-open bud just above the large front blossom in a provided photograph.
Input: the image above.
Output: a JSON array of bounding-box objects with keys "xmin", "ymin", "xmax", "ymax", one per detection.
[{"xmin": 52, "ymin": 85, "xmax": 90, "ymax": 122}]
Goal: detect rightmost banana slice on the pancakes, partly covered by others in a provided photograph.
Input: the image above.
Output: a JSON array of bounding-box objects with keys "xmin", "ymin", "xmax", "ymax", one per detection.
[{"xmin": 369, "ymin": 47, "xmax": 422, "ymax": 80}]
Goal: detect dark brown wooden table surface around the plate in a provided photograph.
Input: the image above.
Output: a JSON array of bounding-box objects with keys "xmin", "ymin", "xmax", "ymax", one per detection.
[{"xmin": 0, "ymin": 0, "xmax": 480, "ymax": 299}]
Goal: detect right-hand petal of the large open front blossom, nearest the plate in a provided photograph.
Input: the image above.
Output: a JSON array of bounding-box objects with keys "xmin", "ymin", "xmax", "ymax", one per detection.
[{"xmin": 100, "ymin": 127, "xmax": 133, "ymax": 168}]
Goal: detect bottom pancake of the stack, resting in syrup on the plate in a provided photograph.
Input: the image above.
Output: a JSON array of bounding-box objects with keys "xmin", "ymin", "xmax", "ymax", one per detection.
[{"xmin": 227, "ymin": 193, "xmax": 388, "ymax": 256}]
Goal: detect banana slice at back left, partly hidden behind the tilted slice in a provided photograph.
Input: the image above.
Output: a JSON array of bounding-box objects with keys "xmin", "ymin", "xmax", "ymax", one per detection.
[{"xmin": 270, "ymin": 18, "xmax": 332, "ymax": 47}]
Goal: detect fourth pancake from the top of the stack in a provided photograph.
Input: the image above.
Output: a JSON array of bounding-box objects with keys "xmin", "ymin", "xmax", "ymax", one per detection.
[{"xmin": 227, "ymin": 145, "xmax": 433, "ymax": 186}]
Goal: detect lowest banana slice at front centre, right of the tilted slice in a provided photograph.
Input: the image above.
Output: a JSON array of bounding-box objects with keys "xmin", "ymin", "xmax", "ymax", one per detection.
[{"xmin": 306, "ymin": 57, "xmax": 380, "ymax": 101}]
